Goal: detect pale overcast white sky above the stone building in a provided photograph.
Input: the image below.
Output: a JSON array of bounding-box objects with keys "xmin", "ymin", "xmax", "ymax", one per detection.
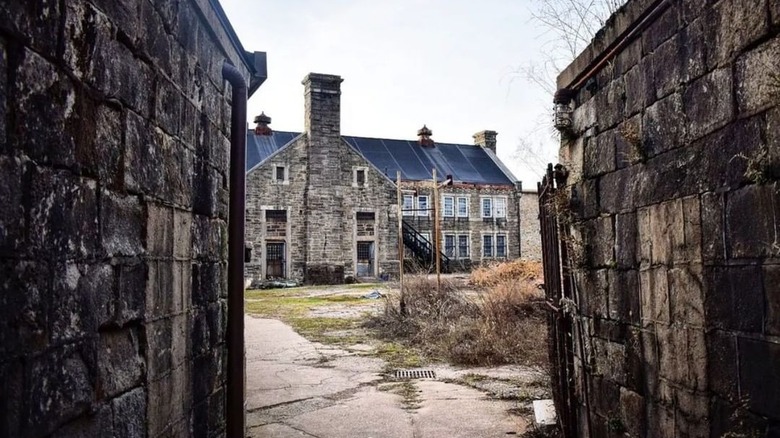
[{"xmin": 221, "ymin": 0, "xmax": 556, "ymax": 189}]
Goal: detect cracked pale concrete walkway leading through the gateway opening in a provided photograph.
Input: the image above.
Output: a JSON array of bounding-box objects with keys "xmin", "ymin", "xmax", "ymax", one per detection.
[{"xmin": 246, "ymin": 316, "xmax": 525, "ymax": 438}]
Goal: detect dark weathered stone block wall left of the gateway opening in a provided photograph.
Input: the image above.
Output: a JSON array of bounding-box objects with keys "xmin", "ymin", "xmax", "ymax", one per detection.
[{"xmin": 0, "ymin": 0, "xmax": 248, "ymax": 437}]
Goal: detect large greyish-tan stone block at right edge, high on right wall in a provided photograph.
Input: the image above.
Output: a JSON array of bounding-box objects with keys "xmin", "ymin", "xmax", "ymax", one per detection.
[{"xmin": 734, "ymin": 38, "xmax": 780, "ymax": 116}]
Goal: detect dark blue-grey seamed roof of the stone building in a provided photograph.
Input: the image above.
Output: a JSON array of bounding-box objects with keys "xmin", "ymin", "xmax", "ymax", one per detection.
[{"xmin": 246, "ymin": 130, "xmax": 514, "ymax": 184}]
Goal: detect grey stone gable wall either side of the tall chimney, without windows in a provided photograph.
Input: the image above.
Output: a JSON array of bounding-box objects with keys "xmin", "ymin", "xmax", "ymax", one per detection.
[{"xmin": 247, "ymin": 135, "xmax": 398, "ymax": 282}]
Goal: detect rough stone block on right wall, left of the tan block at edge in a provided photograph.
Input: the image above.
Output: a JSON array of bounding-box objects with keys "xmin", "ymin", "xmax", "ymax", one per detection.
[{"xmin": 683, "ymin": 68, "xmax": 734, "ymax": 140}]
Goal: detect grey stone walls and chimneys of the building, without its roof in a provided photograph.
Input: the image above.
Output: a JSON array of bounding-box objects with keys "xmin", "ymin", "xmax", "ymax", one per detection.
[{"xmin": 247, "ymin": 73, "xmax": 539, "ymax": 283}]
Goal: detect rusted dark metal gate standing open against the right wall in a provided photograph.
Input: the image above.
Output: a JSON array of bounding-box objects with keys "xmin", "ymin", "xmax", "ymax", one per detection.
[{"xmin": 538, "ymin": 164, "xmax": 577, "ymax": 437}]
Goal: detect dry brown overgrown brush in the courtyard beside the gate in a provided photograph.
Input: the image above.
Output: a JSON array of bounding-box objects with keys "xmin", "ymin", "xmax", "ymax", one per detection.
[{"xmin": 366, "ymin": 261, "xmax": 547, "ymax": 366}]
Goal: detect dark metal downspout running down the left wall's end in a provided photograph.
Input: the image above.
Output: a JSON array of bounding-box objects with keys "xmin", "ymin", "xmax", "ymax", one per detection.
[{"xmin": 222, "ymin": 61, "xmax": 247, "ymax": 438}]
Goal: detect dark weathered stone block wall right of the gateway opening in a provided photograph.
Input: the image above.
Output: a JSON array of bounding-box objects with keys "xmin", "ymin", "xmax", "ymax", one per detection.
[{"xmin": 559, "ymin": 0, "xmax": 780, "ymax": 437}]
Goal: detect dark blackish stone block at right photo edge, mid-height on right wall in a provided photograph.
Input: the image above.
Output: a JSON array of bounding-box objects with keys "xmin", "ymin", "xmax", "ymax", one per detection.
[{"xmin": 725, "ymin": 185, "xmax": 780, "ymax": 258}]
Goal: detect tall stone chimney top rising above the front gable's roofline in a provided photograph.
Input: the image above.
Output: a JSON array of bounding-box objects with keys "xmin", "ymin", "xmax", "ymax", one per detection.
[{"xmin": 302, "ymin": 73, "xmax": 343, "ymax": 139}]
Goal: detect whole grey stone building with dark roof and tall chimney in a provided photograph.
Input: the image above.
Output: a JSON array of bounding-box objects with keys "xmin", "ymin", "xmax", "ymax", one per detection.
[{"xmin": 246, "ymin": 73, "xmax": 538, "ymax": 283}]
